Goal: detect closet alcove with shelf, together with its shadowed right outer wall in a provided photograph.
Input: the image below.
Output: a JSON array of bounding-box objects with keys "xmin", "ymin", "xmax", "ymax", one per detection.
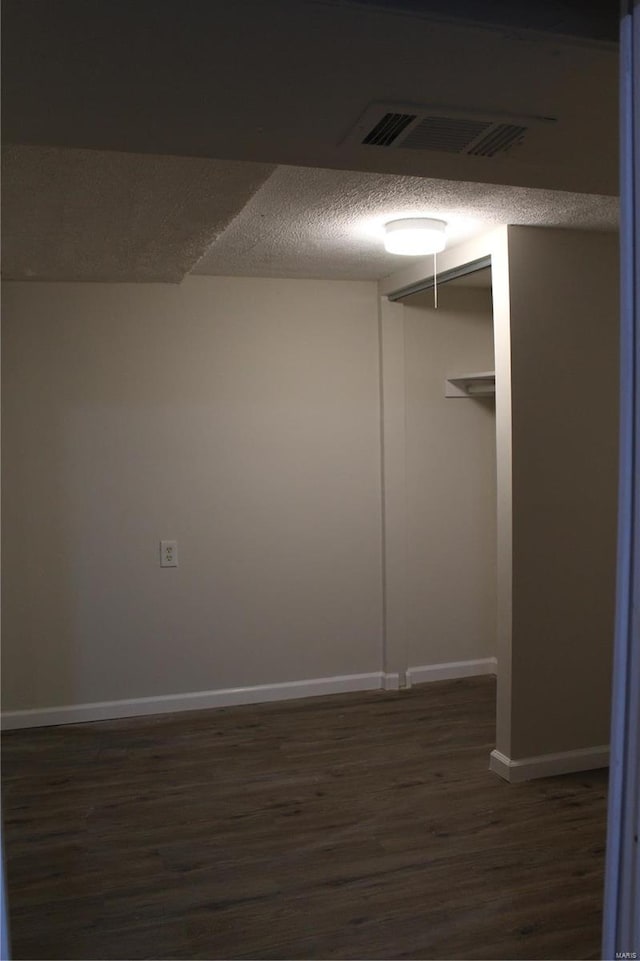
[{"xmin": 379, "ymin": 227, "xmax": 618, "ymax": 781}]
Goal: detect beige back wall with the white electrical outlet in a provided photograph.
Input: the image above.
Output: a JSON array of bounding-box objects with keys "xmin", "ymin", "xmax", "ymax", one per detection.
[{"xmin": 3, "ymin": 278, "xmax": 382, "ymax": 710}]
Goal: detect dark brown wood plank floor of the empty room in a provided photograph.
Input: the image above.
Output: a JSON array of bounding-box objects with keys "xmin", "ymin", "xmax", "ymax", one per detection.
[{"xmin": 3, "ymin": 678, "xmax": 607, "ymax": 961}]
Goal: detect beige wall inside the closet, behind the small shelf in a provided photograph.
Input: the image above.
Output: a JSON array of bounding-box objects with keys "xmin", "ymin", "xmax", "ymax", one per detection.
[{"xmin": 404, "ymin": 285, "xmax": 497, "ymax": 667}]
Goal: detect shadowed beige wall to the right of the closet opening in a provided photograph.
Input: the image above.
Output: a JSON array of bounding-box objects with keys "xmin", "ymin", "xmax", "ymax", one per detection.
[{"xmin": 509, "ymin": 227, "xmax": 618, "ymax": 759}]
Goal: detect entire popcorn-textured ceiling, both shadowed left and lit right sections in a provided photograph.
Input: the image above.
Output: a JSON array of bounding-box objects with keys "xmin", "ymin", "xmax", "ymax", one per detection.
[{"xmin": 3, "ymin": 147, "xmax": 618, "ymax": 282}]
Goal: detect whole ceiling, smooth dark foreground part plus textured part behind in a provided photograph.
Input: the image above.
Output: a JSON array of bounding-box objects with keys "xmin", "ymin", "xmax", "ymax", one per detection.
[{"xmin": 3, "ymin": 0, "xmax": 618, "ymax": 282}]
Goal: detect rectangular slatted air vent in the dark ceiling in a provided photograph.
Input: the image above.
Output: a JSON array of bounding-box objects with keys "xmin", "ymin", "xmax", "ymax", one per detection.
[{"xmin": 345, "ymin": 104, "xmax": 555, "ymax": 157}]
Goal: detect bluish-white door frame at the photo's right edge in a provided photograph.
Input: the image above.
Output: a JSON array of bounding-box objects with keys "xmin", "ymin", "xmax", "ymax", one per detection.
[{"xmin": 602, "ymin": 0, "xmax": 640, "ymax": 958}]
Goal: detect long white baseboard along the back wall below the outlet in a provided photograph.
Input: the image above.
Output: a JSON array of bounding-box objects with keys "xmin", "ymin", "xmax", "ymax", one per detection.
[{"xmin": 2, "ymin": 671, "xmax": 390, "ymax": 731}]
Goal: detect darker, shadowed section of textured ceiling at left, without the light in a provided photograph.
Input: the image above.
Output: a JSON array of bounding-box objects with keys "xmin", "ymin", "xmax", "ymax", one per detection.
[{"xmin": 2, "ymin": 147, "xmax": 274, "ymax": 282}]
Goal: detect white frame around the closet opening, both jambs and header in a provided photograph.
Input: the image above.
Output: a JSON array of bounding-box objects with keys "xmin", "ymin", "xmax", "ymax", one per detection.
[{"xmin": 378, "ymin": 227, "xmax": 513, "ymax": 756}]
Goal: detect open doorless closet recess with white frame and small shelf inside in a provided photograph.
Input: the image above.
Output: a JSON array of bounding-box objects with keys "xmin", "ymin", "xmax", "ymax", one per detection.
[{"xmin": 379, "ymin": 238, "xmax": 512, "ymax": 760}]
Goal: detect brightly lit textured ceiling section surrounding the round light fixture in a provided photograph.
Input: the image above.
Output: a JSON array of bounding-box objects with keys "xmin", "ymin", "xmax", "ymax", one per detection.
[{"xmin": 192, "ymin": 167, "xmax": 618, "ymax": 279}]
